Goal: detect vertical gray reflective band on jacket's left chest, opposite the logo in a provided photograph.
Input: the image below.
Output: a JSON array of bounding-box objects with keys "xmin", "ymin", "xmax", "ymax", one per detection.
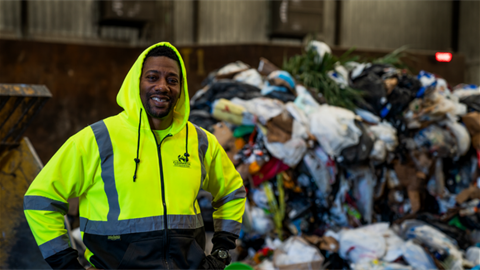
[{"xmin": 91, "ymin": 120, "xmax": 120, "ymax": 221}]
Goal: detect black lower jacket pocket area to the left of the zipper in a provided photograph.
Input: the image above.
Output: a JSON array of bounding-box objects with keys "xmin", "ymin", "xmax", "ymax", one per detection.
[{"xmin": 117, "ymin": 237, "xmax": 164, "ymax": 270}]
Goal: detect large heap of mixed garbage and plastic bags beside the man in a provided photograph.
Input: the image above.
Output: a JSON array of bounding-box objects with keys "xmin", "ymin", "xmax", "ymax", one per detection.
[{"xmin": 190, "ymin": 41, "xmax": 480, "ymax": 270}]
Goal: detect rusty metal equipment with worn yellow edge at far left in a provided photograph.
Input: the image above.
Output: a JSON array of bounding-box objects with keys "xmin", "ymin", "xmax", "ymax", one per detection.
[{"xmin": 0, "ymin": 84, "xmax": 52, "ymax": 269}]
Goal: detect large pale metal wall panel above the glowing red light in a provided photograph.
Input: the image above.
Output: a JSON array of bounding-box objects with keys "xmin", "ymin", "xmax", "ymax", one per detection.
[{"xmin": 341, "ymin": 0, "xmax": 452, "ymax": 50}]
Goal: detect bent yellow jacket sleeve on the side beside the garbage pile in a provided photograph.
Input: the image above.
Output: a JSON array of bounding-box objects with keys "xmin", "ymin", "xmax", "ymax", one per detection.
[{"xmin": 203, "ymin": 133, "xmax": 246, "ymax": 249}]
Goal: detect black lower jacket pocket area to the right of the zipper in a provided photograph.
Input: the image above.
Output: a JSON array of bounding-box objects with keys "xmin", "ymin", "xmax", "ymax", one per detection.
[{"xmin": 168, "ymin": 235, "xmax": 205, "ymax": 270}]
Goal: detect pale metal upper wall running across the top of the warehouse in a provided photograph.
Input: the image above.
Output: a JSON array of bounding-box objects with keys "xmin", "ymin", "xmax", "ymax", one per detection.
[{"xmin": 0, "ymin": 0, "xmax": 480, "ymax": 84}]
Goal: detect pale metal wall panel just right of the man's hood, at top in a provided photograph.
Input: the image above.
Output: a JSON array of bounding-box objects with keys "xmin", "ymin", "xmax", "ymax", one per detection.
[{"xmin": 173, "ymin": 0, "xmax": 270, "ymax": 44}]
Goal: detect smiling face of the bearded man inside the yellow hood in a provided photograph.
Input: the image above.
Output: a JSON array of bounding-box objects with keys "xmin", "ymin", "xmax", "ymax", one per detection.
[{"xmin": 140, "ymin": 56, "xmax": 181, "ymax": 118}]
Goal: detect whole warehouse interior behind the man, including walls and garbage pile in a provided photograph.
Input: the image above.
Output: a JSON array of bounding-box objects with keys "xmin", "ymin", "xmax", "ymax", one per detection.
[{"xmin": 0, "ymin": 0, "xmax": 480, "ymax": 270}]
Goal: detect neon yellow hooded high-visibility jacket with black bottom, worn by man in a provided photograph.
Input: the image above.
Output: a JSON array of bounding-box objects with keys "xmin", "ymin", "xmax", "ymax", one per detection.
[{"xmin": 24, "ymin": 43, "xmax": 246, "ymax": 269}]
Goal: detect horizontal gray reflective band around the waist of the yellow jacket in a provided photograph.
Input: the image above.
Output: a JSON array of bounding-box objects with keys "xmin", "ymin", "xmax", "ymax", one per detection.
[{"xmin": 80, "ymin": 214, "xmax": 203, "ymax": 235}]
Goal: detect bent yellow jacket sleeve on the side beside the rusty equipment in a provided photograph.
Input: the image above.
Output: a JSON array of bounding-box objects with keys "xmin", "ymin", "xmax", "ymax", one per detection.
[{"xmin": 23, "ymin": 130, "xmax": 95, "ymax": 269}]
